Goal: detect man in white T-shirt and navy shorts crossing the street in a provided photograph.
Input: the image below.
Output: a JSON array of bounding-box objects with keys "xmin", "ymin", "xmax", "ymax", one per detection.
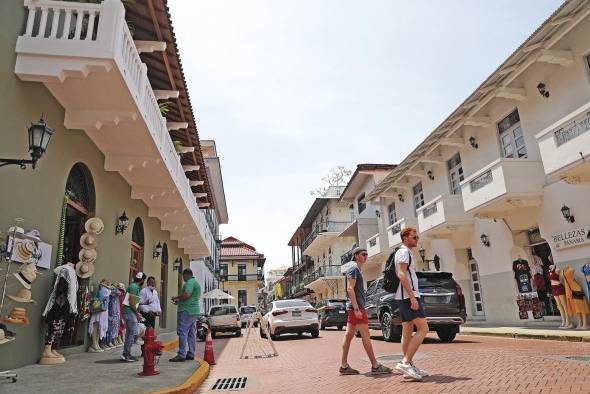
[{"xmin": 395, "ymin": 227, "xmax": 428, "ymax": 380}]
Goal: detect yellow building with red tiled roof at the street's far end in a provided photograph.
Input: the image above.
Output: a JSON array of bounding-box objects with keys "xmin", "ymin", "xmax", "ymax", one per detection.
[{"xmin": 219, "ymin": 237, "xmax": 266, "ymax": 307}]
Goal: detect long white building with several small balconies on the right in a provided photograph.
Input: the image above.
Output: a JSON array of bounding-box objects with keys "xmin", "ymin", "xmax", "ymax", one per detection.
[{"xmin": 366, "ymin": 0, "xmax": 590, "ymax": 324}]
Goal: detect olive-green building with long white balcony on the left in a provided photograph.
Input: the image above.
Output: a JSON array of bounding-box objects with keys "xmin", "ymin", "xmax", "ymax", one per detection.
[{"xmin": 0, "ymin": 0, "xmax": 218, "ymax": 370}]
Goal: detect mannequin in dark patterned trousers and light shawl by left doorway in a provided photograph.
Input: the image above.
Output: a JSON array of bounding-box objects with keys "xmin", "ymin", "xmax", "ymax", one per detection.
[{"xmin": 39, "ymin": 263, "xmax": 78, "ymax": 365}]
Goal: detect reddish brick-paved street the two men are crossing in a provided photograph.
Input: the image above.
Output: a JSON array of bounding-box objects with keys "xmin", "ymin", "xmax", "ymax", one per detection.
[{"xmin": 201, "ymin": 331, "xmax": 590, "ymax": 394}]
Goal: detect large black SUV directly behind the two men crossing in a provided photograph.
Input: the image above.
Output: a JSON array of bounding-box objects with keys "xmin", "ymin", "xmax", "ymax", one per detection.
[{"xmin": 366, "ymin": 272, "xmax": 467, "ymax": 342}]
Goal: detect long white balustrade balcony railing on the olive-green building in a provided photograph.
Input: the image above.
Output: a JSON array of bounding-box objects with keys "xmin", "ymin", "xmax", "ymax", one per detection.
[{"xmin": 15, "ymin": 0, "xmax": 212, "ymax": 255}]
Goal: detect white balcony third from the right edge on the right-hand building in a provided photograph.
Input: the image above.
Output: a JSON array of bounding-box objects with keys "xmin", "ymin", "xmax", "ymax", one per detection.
[{"xmin": 416, "ymin": 194, "xmax": 471, "ymax": 233}]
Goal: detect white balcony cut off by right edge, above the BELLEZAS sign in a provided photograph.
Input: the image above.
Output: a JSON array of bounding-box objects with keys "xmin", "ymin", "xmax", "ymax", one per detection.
[{"xmin": 536, "ymin": 103, "xmax": 590, "ymax": 175}]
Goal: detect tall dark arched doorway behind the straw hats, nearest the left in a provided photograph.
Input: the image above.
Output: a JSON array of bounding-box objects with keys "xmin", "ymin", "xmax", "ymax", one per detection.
[{"xmin": 58, "ymin": 163, "xmax": 96, "ymax": 347}]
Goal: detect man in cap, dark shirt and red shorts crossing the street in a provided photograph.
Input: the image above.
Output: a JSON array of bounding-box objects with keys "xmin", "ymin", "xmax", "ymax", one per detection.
[{"xmin": 340, "ymin": 247, "xmax": 391, "ymax": 375}]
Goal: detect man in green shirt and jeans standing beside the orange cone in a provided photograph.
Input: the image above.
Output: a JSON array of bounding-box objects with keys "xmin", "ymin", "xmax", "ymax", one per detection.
[{"xmin": 170, "ymin": 268, "xmax": 201, "ymax": 362}]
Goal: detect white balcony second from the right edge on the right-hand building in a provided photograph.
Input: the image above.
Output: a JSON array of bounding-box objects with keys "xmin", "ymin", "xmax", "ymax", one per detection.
[{"xmin": 461, "ymin": 159, "xmax": 545, "ymax": 212}]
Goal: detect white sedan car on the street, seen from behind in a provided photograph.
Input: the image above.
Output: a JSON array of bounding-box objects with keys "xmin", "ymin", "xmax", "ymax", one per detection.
[{"xmin": 260, "ymin": 299, "xmax": 320, "ymax": 340}]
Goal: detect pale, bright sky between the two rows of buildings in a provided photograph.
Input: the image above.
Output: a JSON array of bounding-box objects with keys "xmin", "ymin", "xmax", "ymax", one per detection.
[{"xmin": 169, "ymin": 0, "xmax": 561, "ymax": 269}]
